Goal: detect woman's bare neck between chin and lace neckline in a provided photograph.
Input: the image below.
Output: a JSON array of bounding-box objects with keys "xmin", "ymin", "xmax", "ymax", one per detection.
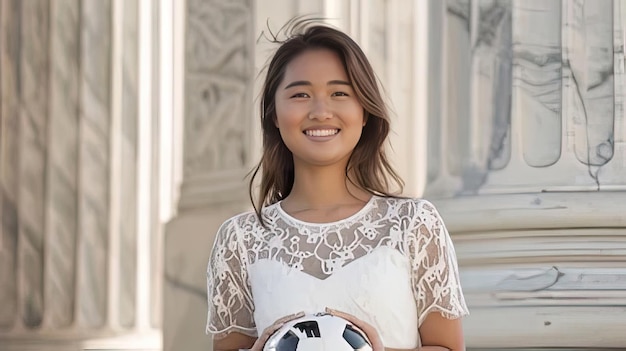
[{"xmin": 285, "ymin": 166, "xmax": 370, "ymax": 209}]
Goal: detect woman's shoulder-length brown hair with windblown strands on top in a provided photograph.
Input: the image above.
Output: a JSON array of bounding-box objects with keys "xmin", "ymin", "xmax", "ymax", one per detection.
[{"xmin": 248, "ymin": 19, "xmax": 404, "ymax": 223}]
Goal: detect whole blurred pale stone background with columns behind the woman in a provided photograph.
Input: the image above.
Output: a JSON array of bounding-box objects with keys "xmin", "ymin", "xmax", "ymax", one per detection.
[{"xmin": 0, "ymin": 0, "xmax": 626, "ymax": 351}]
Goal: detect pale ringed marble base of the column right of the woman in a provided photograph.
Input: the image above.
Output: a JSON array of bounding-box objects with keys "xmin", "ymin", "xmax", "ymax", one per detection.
[{"xmin": 433, "ymin": 191, "xmax": 626, "ymax": 350}]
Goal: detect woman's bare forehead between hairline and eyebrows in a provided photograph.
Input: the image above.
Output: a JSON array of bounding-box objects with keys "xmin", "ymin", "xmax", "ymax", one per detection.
[{"xmin": 283, "ymin": 49, "xmax": 347, "ymax": 83}]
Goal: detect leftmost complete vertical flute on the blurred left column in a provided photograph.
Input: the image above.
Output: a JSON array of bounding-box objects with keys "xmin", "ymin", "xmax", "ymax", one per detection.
[{"xmin": 45, "ymin": 0, "xmax": 80, "ymax": 328}]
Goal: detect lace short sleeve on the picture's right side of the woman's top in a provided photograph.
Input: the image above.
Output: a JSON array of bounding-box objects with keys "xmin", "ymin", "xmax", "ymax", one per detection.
[{"xmin": 409, "ymin": 200, "xmax": 469, "ymax": 325}]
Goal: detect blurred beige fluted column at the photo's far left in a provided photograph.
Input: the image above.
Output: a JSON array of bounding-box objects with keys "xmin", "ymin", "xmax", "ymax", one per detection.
[{"xmin": 0, "ymin": 0, "xmax": 161, "ymax": 351}]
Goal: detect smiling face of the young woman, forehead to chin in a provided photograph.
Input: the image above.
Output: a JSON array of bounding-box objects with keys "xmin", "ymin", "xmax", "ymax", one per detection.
[{"xmin": 275, "ymin": 49, "xmax": 364, "ymax": 167}]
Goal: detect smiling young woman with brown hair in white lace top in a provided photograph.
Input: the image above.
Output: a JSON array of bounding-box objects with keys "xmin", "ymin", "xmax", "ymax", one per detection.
[{"xmin": 207, "ymin": 22, "xmax": 467, "ymax": 351}]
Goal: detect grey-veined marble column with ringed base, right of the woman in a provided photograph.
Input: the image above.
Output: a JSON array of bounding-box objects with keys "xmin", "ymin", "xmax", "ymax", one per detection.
[{"xmin": 425, "ymin": 0, "xmax": 626, "ymax": 349}]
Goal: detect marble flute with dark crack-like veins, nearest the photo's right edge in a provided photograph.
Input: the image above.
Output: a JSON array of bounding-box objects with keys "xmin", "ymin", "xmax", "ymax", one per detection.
[{"xmin": 563, "ymin": 0, "xmax": 615, "ymax": 180}]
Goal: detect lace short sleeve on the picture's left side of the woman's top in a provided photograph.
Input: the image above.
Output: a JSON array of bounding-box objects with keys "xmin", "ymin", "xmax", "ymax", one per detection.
[{"xmin": 206, "ymin": 219, "xmax": 257, "ymax": 337}]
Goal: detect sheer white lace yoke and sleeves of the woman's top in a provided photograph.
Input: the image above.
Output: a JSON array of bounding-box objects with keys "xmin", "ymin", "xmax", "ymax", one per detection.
[{"xmin": 206, "ymin": 196, "xmax": 468, "ymax": 336}]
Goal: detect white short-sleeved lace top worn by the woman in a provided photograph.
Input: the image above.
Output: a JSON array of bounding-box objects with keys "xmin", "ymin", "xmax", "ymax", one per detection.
[{"xmin": 206, "ymin": 196, "xmax": 468, "ymax": 349}]
